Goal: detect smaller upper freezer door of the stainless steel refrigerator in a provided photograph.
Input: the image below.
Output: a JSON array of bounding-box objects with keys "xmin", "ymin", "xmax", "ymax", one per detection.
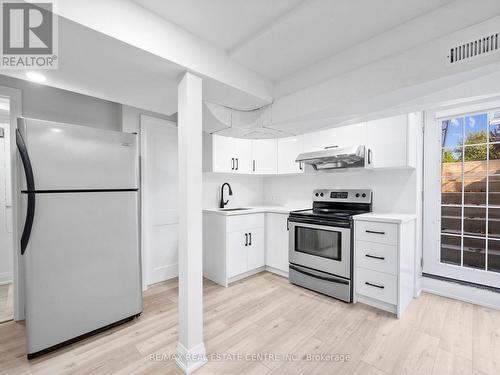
[{"xmin": 18, "ymin": 119, "xmax": 138, "ymax": 190}]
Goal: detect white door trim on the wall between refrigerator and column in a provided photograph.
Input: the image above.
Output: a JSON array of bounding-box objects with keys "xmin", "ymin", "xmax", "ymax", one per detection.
[{"xmin": 139, "ymin": 114, "xmax": 177, "ymax": 290}]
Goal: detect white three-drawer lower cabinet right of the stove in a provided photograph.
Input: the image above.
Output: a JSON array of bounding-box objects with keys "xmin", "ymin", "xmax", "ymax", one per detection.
[{"xmin": 354, "ymin": 214, "xmax": 415, "ymax": 318}]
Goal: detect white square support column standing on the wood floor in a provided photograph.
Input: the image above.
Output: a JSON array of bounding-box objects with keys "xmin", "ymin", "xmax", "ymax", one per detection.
[{"xmin": 177, "ymin": 73, "xmax": 206, "ymax": 374}]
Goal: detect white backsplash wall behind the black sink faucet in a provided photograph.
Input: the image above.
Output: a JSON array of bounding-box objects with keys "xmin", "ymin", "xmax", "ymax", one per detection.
[{"xmin": 203, "ymin": 173, "xmax": 264, "ymax": 208}]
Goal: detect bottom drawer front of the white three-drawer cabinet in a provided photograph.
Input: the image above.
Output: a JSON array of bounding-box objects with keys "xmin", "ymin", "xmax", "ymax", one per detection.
[{"xmin": 354, "ymin": 267, "xmax": 398, "ymax": 305}]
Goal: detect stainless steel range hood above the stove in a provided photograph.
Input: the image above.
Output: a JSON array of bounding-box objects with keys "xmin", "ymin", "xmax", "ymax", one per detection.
[{"xmin": 295, "ymin": 146, "xmax": 365, "ymax": 171}]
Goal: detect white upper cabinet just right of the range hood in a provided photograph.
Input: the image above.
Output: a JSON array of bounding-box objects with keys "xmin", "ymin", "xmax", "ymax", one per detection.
[{"xmin": 365, "ymin": 113, "xmax": 422, "ymax": 169}]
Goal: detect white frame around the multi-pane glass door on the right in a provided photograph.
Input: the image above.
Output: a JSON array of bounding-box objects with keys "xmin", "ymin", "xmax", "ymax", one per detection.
[{"xmin": 422, "ymin": 100, "xmax": 500, "ymax": 290}]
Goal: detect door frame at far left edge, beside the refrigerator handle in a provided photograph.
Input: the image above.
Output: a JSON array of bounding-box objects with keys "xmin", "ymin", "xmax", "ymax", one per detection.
[{"xmin": 0, "ymin": 86, "xmax": 24, "ymax": 321}]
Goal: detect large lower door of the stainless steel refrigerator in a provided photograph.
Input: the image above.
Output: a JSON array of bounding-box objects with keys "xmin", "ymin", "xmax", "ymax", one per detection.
[{"xmin": 22, "ymin": 192, "xmax": 142, "ymax": 354}]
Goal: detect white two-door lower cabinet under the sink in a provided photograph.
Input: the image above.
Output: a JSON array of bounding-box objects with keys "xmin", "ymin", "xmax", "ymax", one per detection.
[{"xmin": 203, "ymin": 212, "xmax": 265, "ymax": 286}]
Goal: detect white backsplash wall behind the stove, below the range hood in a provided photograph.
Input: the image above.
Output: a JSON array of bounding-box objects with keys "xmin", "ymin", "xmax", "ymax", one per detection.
[{"xmin": 263, "ymin": 170, "xmax": 417, "ymax": 213}]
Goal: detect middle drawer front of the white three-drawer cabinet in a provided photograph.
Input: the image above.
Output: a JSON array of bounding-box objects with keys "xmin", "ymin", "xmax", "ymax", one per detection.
[{"xmin": 355, "ymin": 241, "xmax": 399, "ymax": 275}]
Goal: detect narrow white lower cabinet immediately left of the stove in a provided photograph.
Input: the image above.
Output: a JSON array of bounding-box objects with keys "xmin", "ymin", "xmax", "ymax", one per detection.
[{"xmin": 266, "ymin": 212, "xmax": 288, "ymax": 275}]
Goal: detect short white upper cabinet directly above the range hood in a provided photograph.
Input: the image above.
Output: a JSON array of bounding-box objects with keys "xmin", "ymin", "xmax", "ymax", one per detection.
[{"xmin": 303, "ymin": 124, "xmax": 365, "ymax": 152}]
